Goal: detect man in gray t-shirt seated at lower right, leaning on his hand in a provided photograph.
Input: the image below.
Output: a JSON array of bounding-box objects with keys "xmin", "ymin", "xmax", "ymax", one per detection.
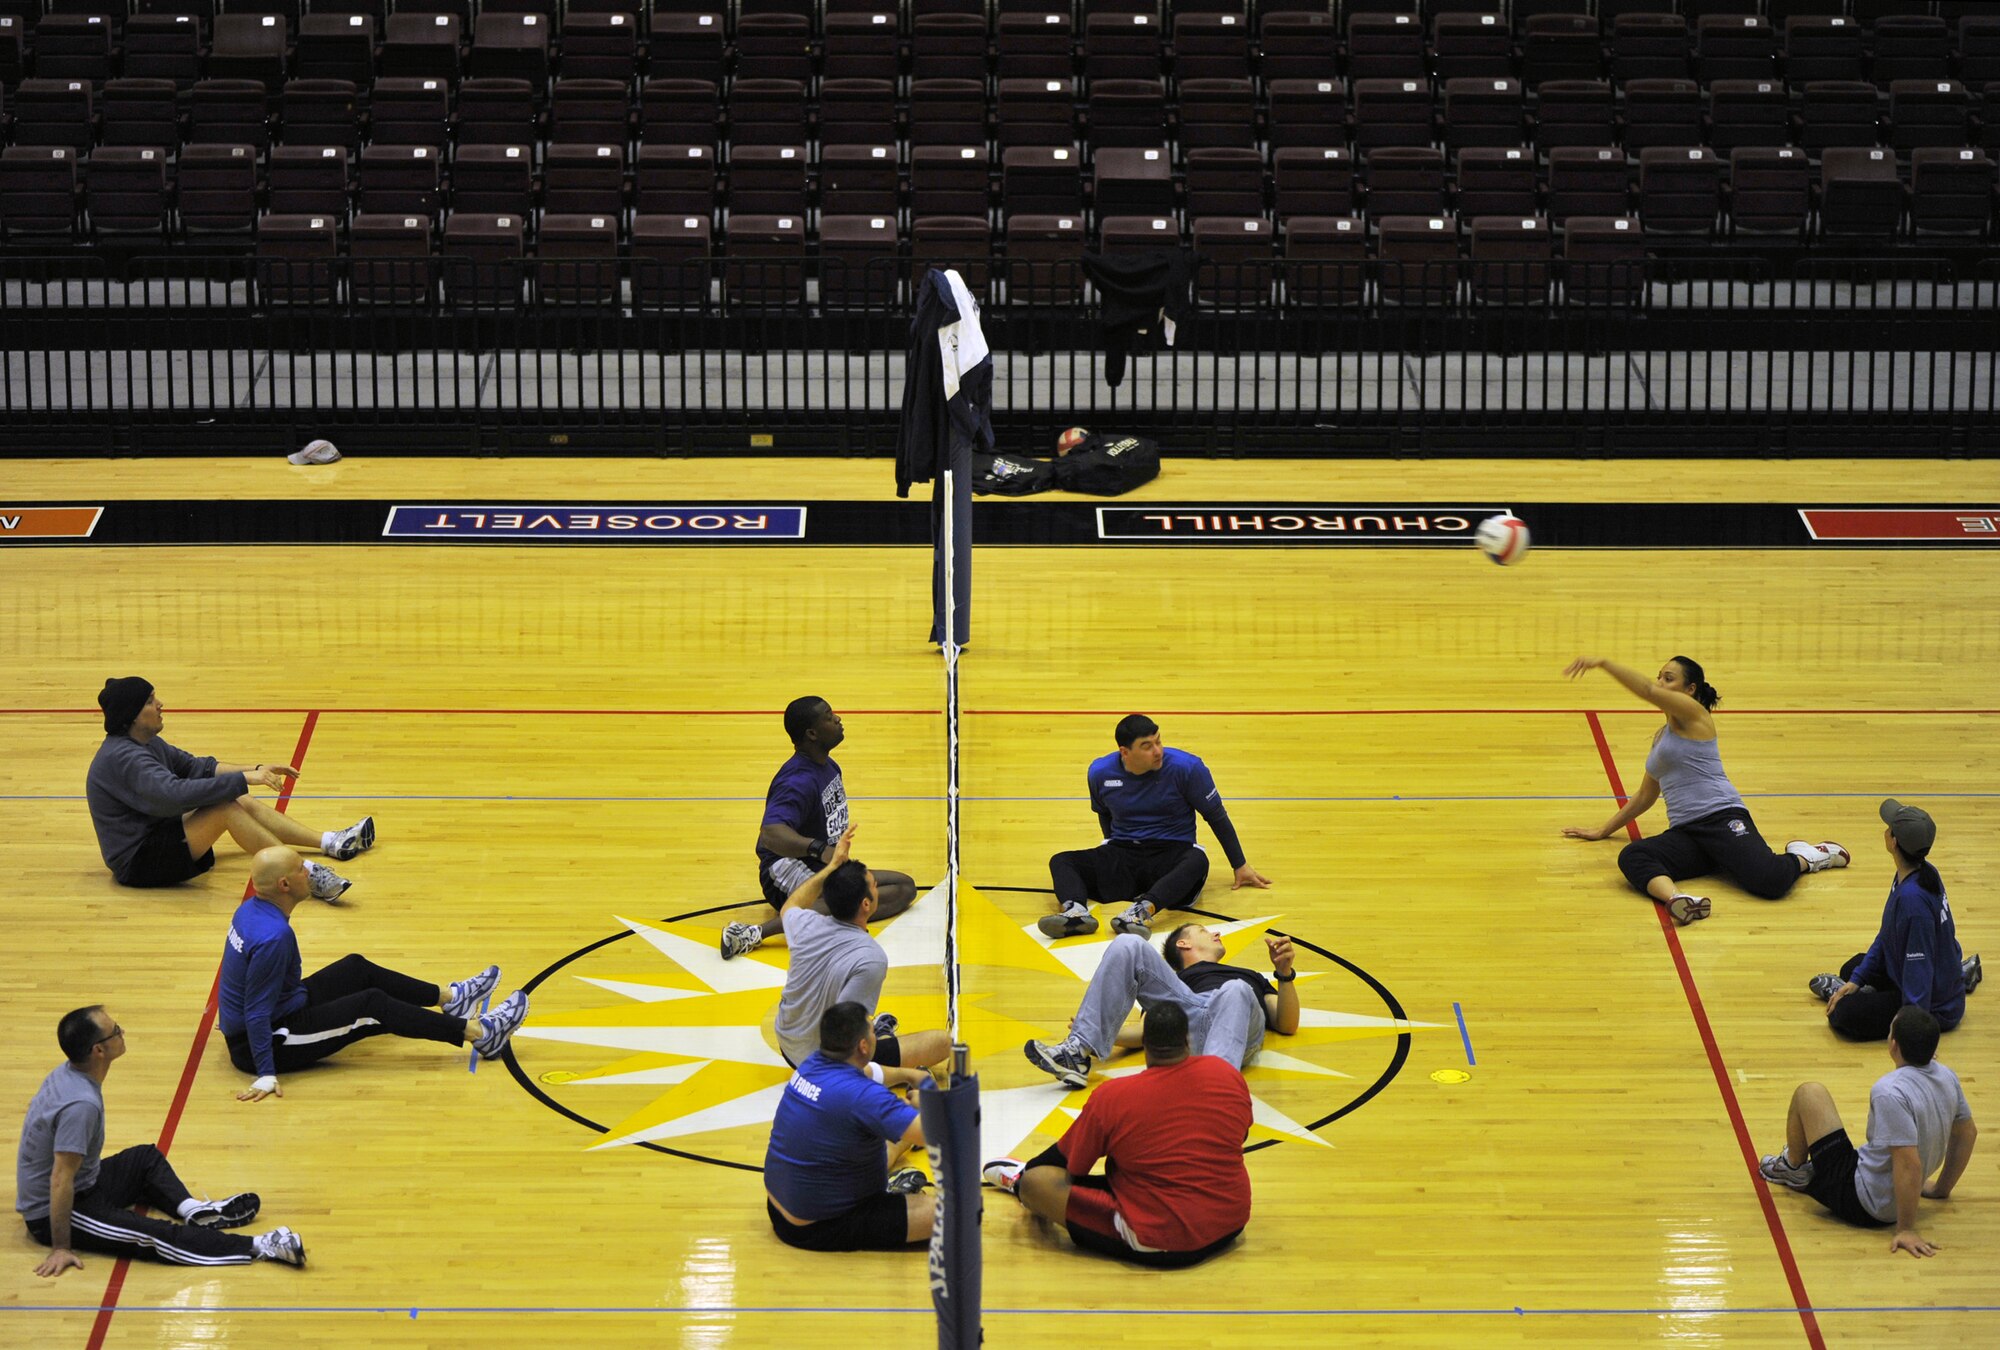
[{"xmin": 1760, "ymin": 1004, "xmax": 1978, "ymax": 1256}]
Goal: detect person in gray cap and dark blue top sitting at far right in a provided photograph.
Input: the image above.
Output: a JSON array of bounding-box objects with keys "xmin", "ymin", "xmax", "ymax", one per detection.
[{"xmin": 1808, "ymin": 798, "xmax": 1982, "ymax": 1040}]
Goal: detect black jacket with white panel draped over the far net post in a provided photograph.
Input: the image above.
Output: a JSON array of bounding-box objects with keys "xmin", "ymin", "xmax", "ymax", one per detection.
[{"xmin": 896, "ymin": 268, "xmax": 994, "ymax": 496}]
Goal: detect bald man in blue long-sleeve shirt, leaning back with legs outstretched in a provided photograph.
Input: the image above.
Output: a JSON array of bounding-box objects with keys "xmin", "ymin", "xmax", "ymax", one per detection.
[{"xmin": 216, "ymin": 844, "xmax": 528, "ymax": 1102}]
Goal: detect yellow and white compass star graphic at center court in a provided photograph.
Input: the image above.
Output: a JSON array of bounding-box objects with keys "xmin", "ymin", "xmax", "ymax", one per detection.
[{"xmin": 514, "ymin": 884, "xmax": 1442, "ymax": 1166}]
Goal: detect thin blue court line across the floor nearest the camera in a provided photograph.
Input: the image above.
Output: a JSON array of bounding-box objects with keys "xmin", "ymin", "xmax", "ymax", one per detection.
[{"xmin": 0, "ymin": 1304, "xmax": 2000, "ymax": 1318}]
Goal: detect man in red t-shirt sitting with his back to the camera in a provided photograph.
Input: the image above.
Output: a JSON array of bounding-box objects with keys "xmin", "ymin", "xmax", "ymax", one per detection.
[{"xmin": 984, "ymin": 1004, "xmax": 1250, "ymax": 1266}]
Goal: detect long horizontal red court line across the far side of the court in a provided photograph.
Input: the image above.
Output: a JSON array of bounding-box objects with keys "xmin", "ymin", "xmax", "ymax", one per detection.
[{"xmin": 0, "ymin": 708, "xmax": 2000, "ymax": 718}]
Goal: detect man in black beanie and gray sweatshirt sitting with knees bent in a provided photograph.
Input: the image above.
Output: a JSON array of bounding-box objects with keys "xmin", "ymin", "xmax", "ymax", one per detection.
[{"xmin": 84, "ymin": 676, "xmax": 374, "ymax": 900}]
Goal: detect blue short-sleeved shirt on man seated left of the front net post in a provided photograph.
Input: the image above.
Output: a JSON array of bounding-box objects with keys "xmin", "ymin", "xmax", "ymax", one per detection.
[{"xmin": 764, "ymin": 1052, "xmax": 916, "ymax": 1224}]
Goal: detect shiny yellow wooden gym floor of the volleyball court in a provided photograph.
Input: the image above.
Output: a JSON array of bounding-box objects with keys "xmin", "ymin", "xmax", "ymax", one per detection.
[{"xmin": 0, "ymin": 460, "xmax": 2000, "ymax": 1348}]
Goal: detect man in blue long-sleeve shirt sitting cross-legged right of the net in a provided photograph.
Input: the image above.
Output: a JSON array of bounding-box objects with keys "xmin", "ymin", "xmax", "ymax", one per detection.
[{"xmin": 1036, "ymin": 712, "xmax": 1270, "ymax": 938}]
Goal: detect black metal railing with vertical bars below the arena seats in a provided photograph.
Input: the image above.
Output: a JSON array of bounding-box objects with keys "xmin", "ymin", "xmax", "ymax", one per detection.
[{"xmin": 0, "ymin": 256, "xmax": 2000, "ymax": 454}]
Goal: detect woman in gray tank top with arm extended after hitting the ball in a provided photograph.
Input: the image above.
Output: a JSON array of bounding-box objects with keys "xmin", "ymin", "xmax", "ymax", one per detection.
[{"xmin": 1564, "ymin": 656, "xmax": 1848, "ymax": 924}]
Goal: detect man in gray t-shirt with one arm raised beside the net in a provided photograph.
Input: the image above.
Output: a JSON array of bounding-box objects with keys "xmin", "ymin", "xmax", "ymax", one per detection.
[{"xmin": 774, "ymin": 826, "xmax": 952, "ymax": 1086}]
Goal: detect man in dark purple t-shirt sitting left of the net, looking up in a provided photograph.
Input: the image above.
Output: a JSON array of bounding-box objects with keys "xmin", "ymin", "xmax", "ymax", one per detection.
[{"xmin": 722, "ymin": 694, "xmax": 916, "ymax": 960}]
